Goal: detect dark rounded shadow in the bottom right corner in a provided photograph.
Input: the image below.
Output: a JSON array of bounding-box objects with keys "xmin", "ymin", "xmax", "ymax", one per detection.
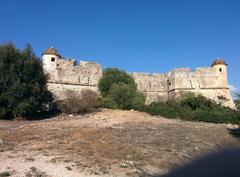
[{"xmin": 152, "ymin": 148, "xmax": 240, "ymax": 177}]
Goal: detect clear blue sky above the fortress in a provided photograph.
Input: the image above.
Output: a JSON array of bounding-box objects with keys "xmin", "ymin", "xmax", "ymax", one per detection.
[{"xmin": 0, "ymin": 0, "xmax": 240, "ymax": 92}]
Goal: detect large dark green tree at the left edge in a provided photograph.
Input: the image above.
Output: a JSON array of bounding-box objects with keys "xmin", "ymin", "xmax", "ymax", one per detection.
[{"xmin": 0, "ymin": 43, "xmax": 52, "ymax": 119}]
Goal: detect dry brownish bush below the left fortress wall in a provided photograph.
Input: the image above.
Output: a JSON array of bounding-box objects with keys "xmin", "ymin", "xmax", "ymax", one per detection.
[{"xmin": 58, "ymin": 90, "xmax": 98, "ymax": 114}]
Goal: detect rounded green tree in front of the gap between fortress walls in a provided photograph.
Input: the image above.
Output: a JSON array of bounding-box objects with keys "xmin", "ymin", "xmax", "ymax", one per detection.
[{"xmin": 99, "ymin": 68, "xmax": 145, "ymax": 110}]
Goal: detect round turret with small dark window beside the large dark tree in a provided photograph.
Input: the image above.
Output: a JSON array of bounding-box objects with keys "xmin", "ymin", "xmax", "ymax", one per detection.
[{"xmin": 42, "ymin": 47, "xmax": 61, "ymax": 70}]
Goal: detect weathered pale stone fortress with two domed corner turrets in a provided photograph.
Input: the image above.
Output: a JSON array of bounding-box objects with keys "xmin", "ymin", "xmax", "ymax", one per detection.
[{"xmin": 42, "ymin": 47, "xmax": 235, "ymax": 108}]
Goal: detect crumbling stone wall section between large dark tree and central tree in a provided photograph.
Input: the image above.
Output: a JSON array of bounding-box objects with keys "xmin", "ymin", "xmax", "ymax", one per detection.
[{"xmin": 43, "ymin": 55, "xmax": 102, "ymax": 99}]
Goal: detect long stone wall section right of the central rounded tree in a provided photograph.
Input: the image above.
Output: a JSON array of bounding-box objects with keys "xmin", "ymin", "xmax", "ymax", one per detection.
[{"xmin": 132, "ymin": 66, "xmax": 235, "ymax": 108}]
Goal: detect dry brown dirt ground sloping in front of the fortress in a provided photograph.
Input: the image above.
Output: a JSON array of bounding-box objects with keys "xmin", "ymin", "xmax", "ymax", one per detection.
[{"xmin": 0, "ymin": 109, "xmax": 240, "ymax": 177}]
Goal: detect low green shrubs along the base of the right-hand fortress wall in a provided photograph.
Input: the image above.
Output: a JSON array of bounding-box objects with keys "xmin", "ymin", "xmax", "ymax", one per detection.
[{"xmin": 140, "ymin": 93, "xmax": 240, "ymax": 124}]
